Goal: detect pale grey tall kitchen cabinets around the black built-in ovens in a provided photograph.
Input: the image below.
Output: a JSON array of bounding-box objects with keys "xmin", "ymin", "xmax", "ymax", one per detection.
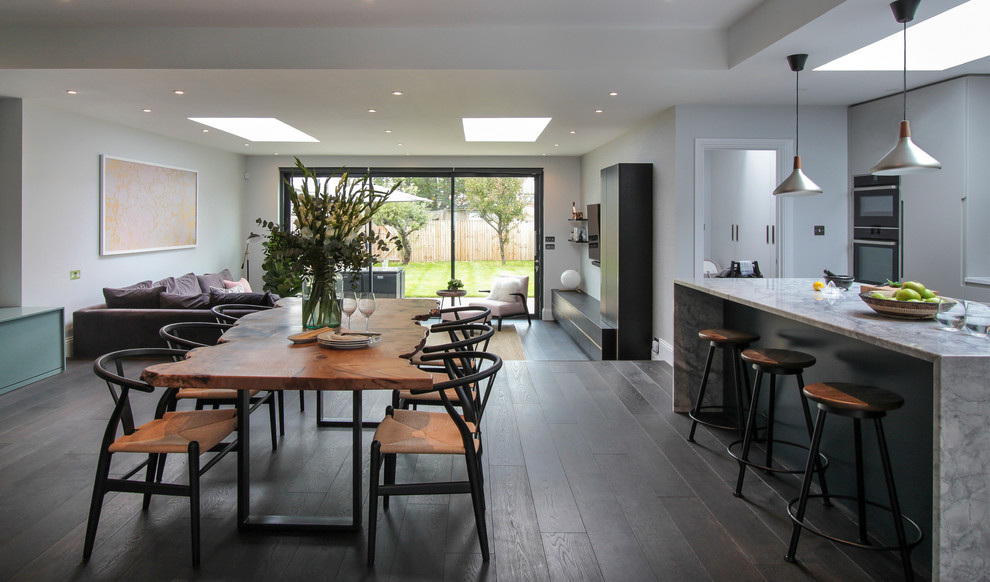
[{"xmin": 849, "ymin": 77, "xmax": 990, "ymax": 301}]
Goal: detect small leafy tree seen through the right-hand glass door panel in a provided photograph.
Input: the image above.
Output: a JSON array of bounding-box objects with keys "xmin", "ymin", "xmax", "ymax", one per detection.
[{"xmin": 458, "ymin": 176, "xmax": 526, "ymax": 265}]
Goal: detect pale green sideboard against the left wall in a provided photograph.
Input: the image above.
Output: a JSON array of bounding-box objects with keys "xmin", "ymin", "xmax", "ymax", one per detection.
[{"xmin": 0, "ymin": 307, "xmax": 65, "ymax": 394}]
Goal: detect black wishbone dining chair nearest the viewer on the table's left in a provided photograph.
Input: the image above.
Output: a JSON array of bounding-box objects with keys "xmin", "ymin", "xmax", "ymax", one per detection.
[{"xmin": 83, "ymin": 348, "xmax": 237, "ymax": 566}]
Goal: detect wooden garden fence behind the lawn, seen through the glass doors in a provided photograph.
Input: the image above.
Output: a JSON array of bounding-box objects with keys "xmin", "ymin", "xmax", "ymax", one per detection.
[{"xmin": 384, "ymin": 218, "xmax": 536, "ymax": 263}]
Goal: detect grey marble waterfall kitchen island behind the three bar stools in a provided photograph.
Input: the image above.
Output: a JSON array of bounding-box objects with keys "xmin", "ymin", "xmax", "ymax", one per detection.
[{"xmin": 674, "ymin": 279, "xmax": 990, "ymax": 580}]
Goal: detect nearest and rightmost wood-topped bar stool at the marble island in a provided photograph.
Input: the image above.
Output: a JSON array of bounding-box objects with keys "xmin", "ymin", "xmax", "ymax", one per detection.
[{"xmin": 784, "ymin": 382, "xmax": 924, "ymax": 580}]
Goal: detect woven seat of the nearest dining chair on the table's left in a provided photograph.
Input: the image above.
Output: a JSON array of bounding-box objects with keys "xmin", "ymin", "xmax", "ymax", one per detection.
[{"xmin": 109, "ymin": 409, "xmax": 238, "ymax": 454}]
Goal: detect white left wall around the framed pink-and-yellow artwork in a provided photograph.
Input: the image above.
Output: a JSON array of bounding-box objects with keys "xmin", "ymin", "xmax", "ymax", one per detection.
[{"xmin": 21, "ymin": 101, "xmax": 245, "ymax": 336}]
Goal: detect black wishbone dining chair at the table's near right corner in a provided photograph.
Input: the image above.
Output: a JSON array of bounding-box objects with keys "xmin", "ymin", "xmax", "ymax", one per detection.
[{"xmin": 368, "ymin": 351, "xmax": 502, "ymax": 566}]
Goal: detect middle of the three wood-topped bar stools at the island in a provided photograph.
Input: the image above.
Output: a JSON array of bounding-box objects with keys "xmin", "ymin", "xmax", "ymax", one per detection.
[{"xmin": 726, "ymin": 348, "xmax": 829, "ymax": 505}]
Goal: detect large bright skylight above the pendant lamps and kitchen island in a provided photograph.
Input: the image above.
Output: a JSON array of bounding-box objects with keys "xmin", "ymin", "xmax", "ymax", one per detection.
[{"xmin": 815, "ymin": 0, "xmax": 990, "ymax": 71}]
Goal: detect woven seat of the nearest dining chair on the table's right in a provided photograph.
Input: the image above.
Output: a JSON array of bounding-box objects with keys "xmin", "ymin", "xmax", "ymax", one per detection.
[{"xmin": 374, "ymin": 409, "xmax": 481, "ymax": 455}]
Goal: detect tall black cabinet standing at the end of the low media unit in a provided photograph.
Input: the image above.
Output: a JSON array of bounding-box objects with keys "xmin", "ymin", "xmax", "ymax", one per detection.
[{"xmin": 600, "ymin": 164, "xmax": 653, "ymax": 360}]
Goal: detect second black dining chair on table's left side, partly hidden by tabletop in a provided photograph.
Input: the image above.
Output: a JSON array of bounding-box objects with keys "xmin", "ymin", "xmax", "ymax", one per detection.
[{"xmin": 158, "ymin": 321, "xmax": 285, "ymax": 451}]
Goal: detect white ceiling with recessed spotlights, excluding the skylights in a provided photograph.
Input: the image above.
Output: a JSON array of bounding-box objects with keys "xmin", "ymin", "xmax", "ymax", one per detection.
[{"xmin": 0, "ymin": 0, "xmax": 990, "ymax": 155}]
